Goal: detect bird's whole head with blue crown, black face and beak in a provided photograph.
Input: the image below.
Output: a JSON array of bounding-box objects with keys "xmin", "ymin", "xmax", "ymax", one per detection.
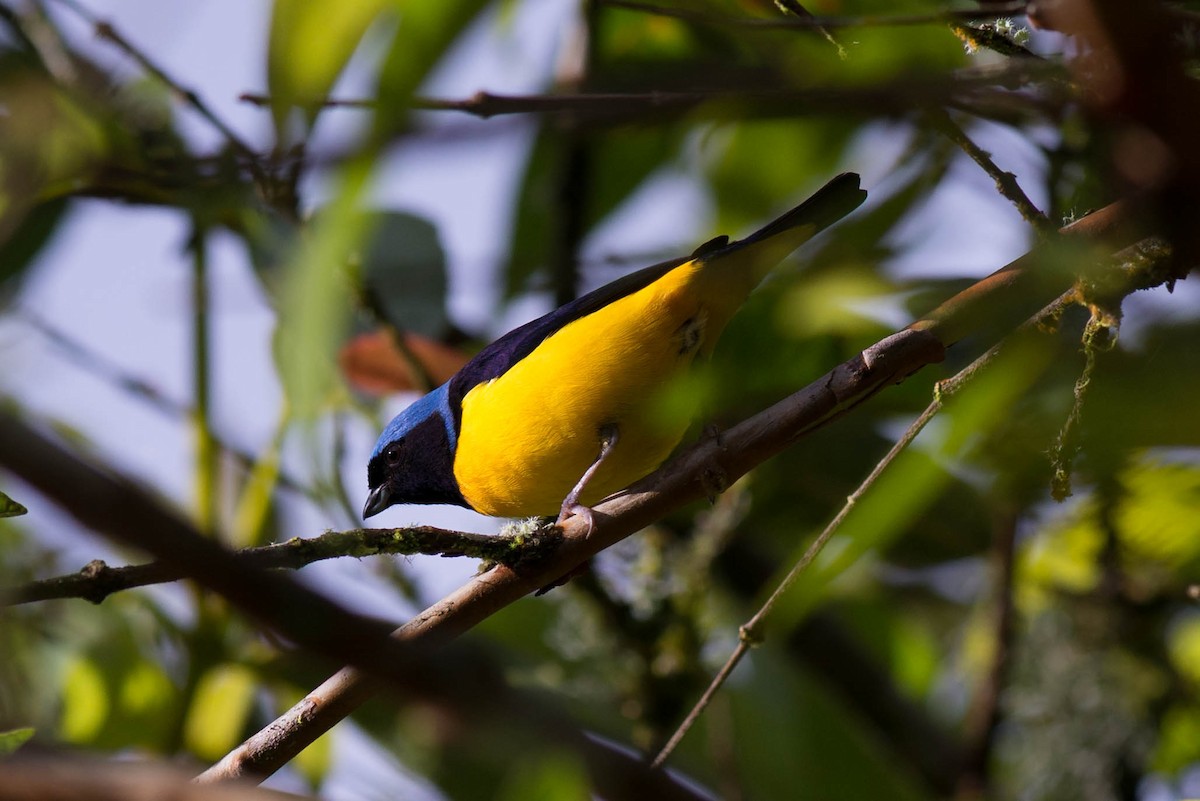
[{"xmin": 362, "ymin": 385, "xmax": 467, "ymax": 518}]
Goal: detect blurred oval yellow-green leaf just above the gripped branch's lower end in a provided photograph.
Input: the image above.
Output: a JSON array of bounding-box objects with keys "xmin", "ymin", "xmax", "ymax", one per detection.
[{"xmin": 184, "ymin": 663, "xmax": 256, "ymax": 760}]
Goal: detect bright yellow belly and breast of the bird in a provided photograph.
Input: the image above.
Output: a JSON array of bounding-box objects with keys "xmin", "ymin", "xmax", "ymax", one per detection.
[{"xmin": 454, "ymin": 263, "xmax": 724, "ymax": 517}]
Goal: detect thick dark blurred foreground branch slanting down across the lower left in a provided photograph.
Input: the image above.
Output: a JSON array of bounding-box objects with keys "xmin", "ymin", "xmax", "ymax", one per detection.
[{"xmin": 0, "ymin": 412, "xmax": 697, "ymax": 801}]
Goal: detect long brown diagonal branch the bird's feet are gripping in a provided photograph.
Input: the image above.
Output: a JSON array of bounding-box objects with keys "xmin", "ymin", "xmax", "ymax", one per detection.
[{"xmin": 198, "ymin": 196, "xmax": 1180, "ymax": 782}]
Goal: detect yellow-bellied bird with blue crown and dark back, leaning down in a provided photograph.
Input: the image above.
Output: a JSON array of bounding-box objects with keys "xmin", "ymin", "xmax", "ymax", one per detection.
[{"xmin": 362, "ymin": 173, "xmax": 866, "ymax": 534}]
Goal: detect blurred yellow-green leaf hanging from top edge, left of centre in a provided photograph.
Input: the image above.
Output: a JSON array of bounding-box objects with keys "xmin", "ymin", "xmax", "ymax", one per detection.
[{"xmin": 266, "ymin": 0, "xmax": 388, "ymax": 144}]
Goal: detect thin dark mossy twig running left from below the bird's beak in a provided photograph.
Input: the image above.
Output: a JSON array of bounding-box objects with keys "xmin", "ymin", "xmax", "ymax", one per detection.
[{"xmin": 0, "ymin": 526, "xmax": 559, "ymax": 606}]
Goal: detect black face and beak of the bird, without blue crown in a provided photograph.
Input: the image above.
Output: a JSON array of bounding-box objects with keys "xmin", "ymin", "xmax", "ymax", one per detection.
[{"xmin": 362, "ymin": 414, "xmax": 467, "ymax": 517}]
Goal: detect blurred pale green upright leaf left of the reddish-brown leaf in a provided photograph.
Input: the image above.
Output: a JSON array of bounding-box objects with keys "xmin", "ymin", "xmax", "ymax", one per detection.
[{"xmin": 275, "ymin": 155, "xmax": 372, "ymax": 420}]
